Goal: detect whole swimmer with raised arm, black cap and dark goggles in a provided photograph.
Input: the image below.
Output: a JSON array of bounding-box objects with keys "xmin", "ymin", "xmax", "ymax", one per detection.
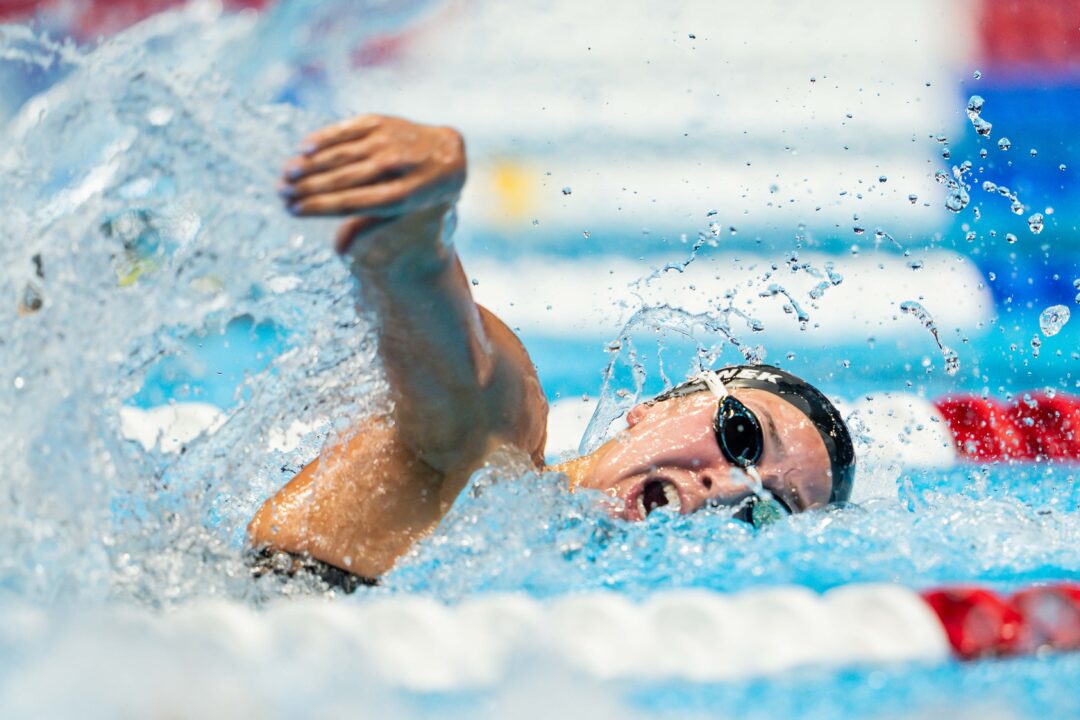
[{"xmin": 248, "ymin": 116, "xmax": 855, "ymax": 589}]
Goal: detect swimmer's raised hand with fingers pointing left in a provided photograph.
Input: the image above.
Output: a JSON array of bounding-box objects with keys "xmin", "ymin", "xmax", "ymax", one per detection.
[{"xmin": 280, "ymin": 116, "xmax": 465, "ymax": 252}]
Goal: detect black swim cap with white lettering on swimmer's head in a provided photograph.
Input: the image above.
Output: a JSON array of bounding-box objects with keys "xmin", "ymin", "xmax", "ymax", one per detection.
[{"xmin": 656, "ymin": 365, "xmax": 855, "ymax": 502}]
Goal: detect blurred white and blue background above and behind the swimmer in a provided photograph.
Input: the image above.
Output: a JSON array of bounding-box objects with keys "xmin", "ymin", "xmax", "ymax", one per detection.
[{"xmin": 0, "ymin": 0, "xmax": 1080, "ymax": 445}]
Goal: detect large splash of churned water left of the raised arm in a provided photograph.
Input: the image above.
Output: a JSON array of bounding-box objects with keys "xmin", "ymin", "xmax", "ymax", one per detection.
[{"xmin": 0, "ymin": 10, "xmax": 412, "ymax": 604}]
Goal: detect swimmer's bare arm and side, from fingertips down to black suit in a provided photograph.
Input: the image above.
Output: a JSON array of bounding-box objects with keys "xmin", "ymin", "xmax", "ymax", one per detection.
[{"xmin": 249, "ymin": 116, "xmax": 546, "ymax": 576}]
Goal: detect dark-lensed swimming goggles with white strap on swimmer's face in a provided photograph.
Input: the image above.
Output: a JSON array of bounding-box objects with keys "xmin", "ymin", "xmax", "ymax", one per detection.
[{"xmin": 653, "ymin": 371, "xmax": 792, "ymax": 528}]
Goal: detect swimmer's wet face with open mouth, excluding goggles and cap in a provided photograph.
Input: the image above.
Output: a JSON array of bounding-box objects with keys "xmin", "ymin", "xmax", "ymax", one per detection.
[{"xmin": 581, "ymin": 389, "xmax": 832, "ymax": 520}]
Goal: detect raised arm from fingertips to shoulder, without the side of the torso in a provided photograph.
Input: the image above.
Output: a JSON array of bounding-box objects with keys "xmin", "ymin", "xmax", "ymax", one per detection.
[{"xmin": 283, "ymin": 116, "xmax": 546, "ymax": 474}]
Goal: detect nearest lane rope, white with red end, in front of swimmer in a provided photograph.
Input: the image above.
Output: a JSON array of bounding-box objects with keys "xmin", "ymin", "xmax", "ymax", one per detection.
[{"xmin": 6, "ymin": 584, "xmax": 1080, "ymax": 692}]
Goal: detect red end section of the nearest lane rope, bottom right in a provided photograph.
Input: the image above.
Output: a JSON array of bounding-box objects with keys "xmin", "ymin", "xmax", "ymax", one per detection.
[{"xmin": 922, "ymin": 583, "xmax": 1080, "ymax": 660}]
